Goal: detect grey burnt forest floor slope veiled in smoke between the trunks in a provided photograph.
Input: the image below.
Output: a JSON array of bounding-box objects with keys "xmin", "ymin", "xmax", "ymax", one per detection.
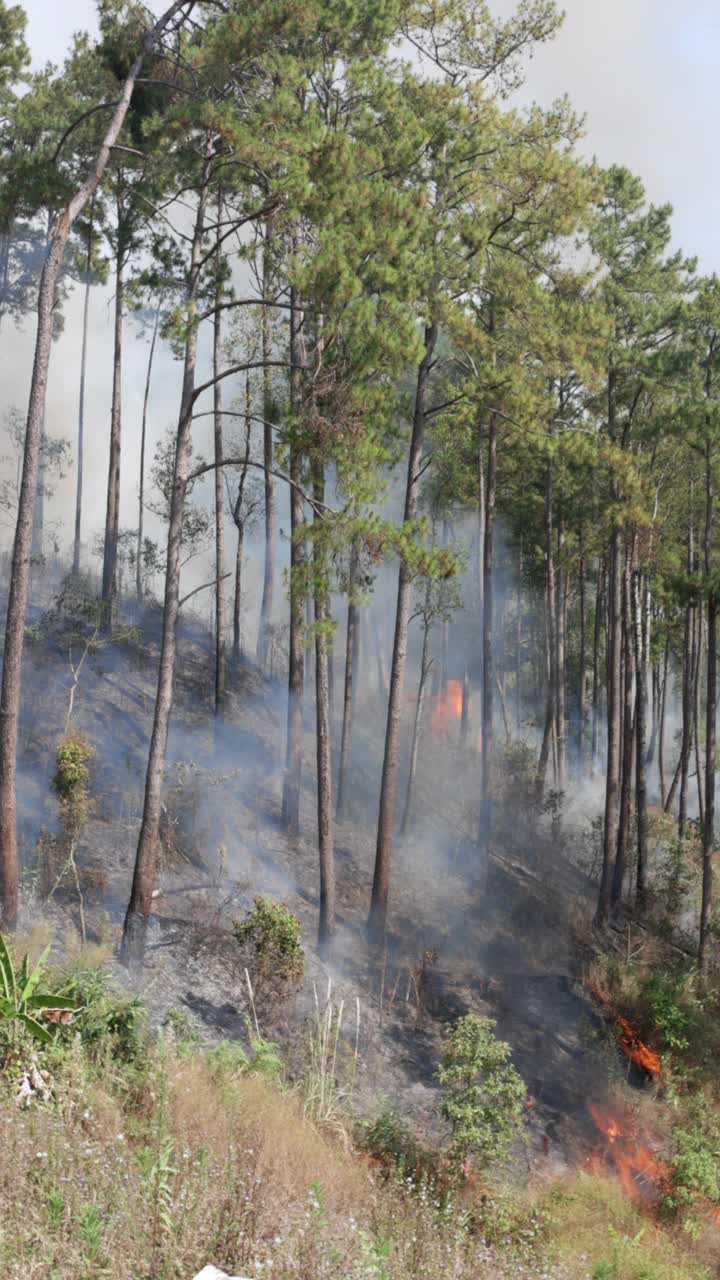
[{"xmin": 12, "ymin": 583, "xmax": 623, "ymax": 1175}]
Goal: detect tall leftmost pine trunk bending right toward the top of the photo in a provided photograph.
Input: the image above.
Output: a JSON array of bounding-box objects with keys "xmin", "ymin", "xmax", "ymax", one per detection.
[{"xmin": 0, "ymin": 0, "xmax": 186, "ymax": 929}]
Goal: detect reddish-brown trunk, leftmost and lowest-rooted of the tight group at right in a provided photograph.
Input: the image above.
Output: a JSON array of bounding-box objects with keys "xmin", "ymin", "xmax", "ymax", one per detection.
[{"xmin": 596, "ymin": 360, "xmax": 623, "ymax": 928}]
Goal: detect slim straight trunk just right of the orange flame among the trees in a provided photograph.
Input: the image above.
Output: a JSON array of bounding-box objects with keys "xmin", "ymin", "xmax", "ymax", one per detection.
[{"xmin": 478, "ymin": 413, "xmax": 497, "ymax": 860}]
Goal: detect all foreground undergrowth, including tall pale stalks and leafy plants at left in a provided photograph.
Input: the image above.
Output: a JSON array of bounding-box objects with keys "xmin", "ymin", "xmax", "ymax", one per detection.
[{"xmin": 0, "ymin": 931, "xmax": 714, "ymax": 1280}]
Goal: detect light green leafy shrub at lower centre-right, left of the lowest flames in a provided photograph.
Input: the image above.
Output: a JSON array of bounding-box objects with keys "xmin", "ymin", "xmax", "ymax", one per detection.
[{"xmin": 437, "ymin": 1014, "xmax": 527, "ymax": 1166}]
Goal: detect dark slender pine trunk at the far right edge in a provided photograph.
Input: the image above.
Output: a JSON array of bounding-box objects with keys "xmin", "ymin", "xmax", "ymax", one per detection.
[{"xmin": 698, "ymin": 435, "xmax": 717, "ymax": 975}]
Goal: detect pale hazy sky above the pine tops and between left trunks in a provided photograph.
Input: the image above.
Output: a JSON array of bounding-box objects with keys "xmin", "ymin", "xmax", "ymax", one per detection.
[{"xmin": 3, "ymin": 0, "xmax": 720, "ymax": 586}]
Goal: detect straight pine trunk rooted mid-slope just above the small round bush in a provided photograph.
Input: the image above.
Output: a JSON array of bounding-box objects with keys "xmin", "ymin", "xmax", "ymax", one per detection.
[{"xmin": 282, "ymin": 289, "xmax": 305, "ymax": 835}]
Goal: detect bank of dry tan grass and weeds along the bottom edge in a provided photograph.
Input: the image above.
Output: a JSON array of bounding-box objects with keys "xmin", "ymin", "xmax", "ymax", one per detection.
[{"xmin": 0, "ymin": 1039, "xmax": 714, "ymax": 1280}]
